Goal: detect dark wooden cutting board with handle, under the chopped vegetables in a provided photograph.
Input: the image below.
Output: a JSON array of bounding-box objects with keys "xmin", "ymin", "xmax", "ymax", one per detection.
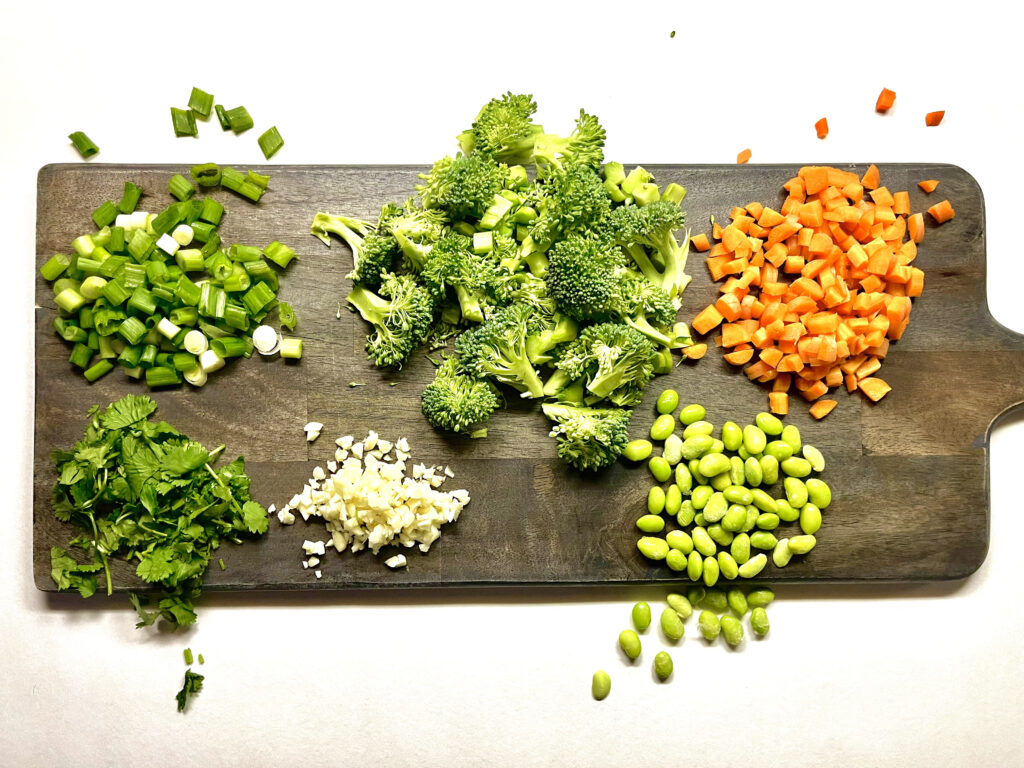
[{"xmin": 33, "ymin": 164, "xmax": 1024, "ymax": 590}]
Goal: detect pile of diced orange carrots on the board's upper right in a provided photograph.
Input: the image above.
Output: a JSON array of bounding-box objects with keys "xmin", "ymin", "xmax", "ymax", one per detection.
[{"xmin": 691, "ymin": 165, "xmax": 952, "ymax": 419}]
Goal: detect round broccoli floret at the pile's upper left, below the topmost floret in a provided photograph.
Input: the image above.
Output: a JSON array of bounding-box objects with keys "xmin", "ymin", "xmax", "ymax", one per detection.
[{"xmin": 416, "ymin": 153, "xmax": 508, "ymax": 221}]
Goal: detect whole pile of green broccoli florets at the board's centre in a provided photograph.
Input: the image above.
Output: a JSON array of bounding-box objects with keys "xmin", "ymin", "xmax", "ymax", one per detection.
[{"xmin": 312, "ymin": 93, "xmax": 692, "ymax": 470}]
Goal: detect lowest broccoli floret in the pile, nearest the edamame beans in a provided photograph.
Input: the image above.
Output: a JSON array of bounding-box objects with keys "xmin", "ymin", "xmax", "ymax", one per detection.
[{"xmin": 542, "ymin": 402, "xmax": 633, "ymax": 470}]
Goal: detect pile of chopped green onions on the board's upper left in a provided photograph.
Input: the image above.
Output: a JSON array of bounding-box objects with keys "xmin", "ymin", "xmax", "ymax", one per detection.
[{"xmin": 40, "ymin": 164, "xmax": 302, "ymax": 387}]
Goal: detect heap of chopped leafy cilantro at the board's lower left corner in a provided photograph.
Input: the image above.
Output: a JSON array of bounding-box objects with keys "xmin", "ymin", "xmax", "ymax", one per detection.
[{"xmin": 50, "ymin": 394, "xmax": 267, "ymax": 627}]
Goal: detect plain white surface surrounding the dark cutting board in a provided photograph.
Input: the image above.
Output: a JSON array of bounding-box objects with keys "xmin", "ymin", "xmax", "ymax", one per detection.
[{"xmin": 0, "ymin": 0, "xmax": 1024, "ymax": 766}]
